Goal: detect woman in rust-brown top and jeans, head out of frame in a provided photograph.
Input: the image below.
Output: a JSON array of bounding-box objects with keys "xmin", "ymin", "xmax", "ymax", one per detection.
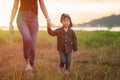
[{"xmin": 9, "ymin": 0, "xmax": 51, "ymax": 70}]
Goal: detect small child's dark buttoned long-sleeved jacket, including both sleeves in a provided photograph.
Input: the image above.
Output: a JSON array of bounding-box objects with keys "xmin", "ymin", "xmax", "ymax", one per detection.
[{"xmin": 47, "ymin": 27, "xmax": 77, "ymax": 53}]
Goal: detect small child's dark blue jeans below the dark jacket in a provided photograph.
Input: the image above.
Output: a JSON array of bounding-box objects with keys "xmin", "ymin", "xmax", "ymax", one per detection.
[{"xmin": 59, "ymin": 51, "xmax": 71, "ymax": 70}]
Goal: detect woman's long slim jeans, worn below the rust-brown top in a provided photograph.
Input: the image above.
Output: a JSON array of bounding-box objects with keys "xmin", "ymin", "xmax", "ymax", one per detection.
[{"xmin": 17, "ymin": 11, "xmax": 39, "ymax": 66}]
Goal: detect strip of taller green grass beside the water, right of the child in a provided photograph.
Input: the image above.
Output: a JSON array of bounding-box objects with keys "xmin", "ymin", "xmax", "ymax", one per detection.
[{"xmin": 77, "ymin": 31, "xmax": 120, "ymax": 48}]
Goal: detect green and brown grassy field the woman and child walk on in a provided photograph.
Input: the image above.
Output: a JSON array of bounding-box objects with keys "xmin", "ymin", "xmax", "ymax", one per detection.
[{"xmin": 0, "ymin": 31, "xmax": 120, "ymax": 80}]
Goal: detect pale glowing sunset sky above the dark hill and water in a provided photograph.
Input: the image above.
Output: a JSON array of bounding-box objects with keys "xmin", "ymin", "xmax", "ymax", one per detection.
[{"xmin": 0, "ymin": 0, "xmax": 120, "ymax": 27}]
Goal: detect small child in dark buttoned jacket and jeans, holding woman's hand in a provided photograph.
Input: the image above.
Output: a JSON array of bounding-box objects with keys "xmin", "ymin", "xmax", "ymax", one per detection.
[{"xmin": 47, "ymin": 14, "xmax": 77, "ymax": 74}]
